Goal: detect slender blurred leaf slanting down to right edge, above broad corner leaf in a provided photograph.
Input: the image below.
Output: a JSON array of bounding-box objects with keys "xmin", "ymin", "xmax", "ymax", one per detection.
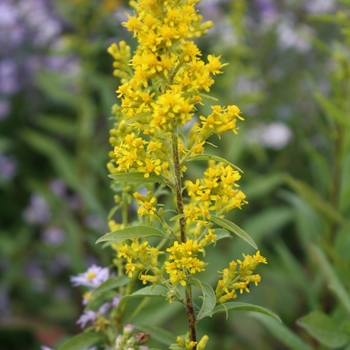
[{"xmin": 311, "ymin": 246, "xmax": 350, "ymax": 314}]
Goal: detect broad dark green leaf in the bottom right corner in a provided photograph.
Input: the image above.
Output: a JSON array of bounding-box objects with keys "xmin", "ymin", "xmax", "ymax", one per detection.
[{"xmin": 297, "ymin": 311, "xmax": 350, "ymax": 349}]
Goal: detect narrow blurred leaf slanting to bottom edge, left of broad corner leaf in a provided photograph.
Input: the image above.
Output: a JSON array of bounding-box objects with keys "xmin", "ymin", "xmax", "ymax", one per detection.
[{"xmin": 252, "ymin": 314, "xmax": 312, "ymax": 350}]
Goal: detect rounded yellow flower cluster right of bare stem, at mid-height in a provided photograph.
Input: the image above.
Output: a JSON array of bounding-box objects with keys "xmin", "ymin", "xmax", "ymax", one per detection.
[{"xmin": 184, "ymin": 161, "xmax": 247, "ymax": 224}]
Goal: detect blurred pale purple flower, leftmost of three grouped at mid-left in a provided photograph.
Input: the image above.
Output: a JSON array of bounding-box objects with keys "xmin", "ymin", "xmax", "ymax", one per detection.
[{"xmin": 23, "ymin": 194, "xmax": 51, "ymax": 225}]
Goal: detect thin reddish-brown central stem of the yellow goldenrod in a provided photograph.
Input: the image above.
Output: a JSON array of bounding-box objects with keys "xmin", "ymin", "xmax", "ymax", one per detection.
[{"xmin": 172, "ymin": 132, "xmax": 197, "ymax": 350}]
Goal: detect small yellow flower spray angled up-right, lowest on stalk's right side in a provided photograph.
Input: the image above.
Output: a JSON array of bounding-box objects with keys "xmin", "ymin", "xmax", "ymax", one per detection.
[{"xmin": 215, "ymin": 251, "xmax": 267, "ymax": 303}]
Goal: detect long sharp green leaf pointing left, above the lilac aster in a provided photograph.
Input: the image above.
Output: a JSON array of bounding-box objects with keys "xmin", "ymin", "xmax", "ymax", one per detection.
[{"xmin": 96, "ymin": 225, "xmax": 167, "ymax": 243}]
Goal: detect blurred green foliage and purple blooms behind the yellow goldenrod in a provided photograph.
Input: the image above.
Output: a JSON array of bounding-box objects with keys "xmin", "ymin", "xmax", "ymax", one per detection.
[{"xmin": 0, "ymin": 0, "xmax": 350, "ymax": 350}]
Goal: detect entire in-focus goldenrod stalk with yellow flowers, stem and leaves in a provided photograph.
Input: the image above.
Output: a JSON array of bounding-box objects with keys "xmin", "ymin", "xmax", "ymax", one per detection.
[{"xmin": 99, "ymin": 0, "xmax": 266, "ymax": 350}]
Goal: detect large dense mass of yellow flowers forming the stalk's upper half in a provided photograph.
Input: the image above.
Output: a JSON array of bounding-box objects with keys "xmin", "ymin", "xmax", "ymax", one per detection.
[{"xmin": 108, "ymin": 0, "xmax": 242, "ymax": 179}]
